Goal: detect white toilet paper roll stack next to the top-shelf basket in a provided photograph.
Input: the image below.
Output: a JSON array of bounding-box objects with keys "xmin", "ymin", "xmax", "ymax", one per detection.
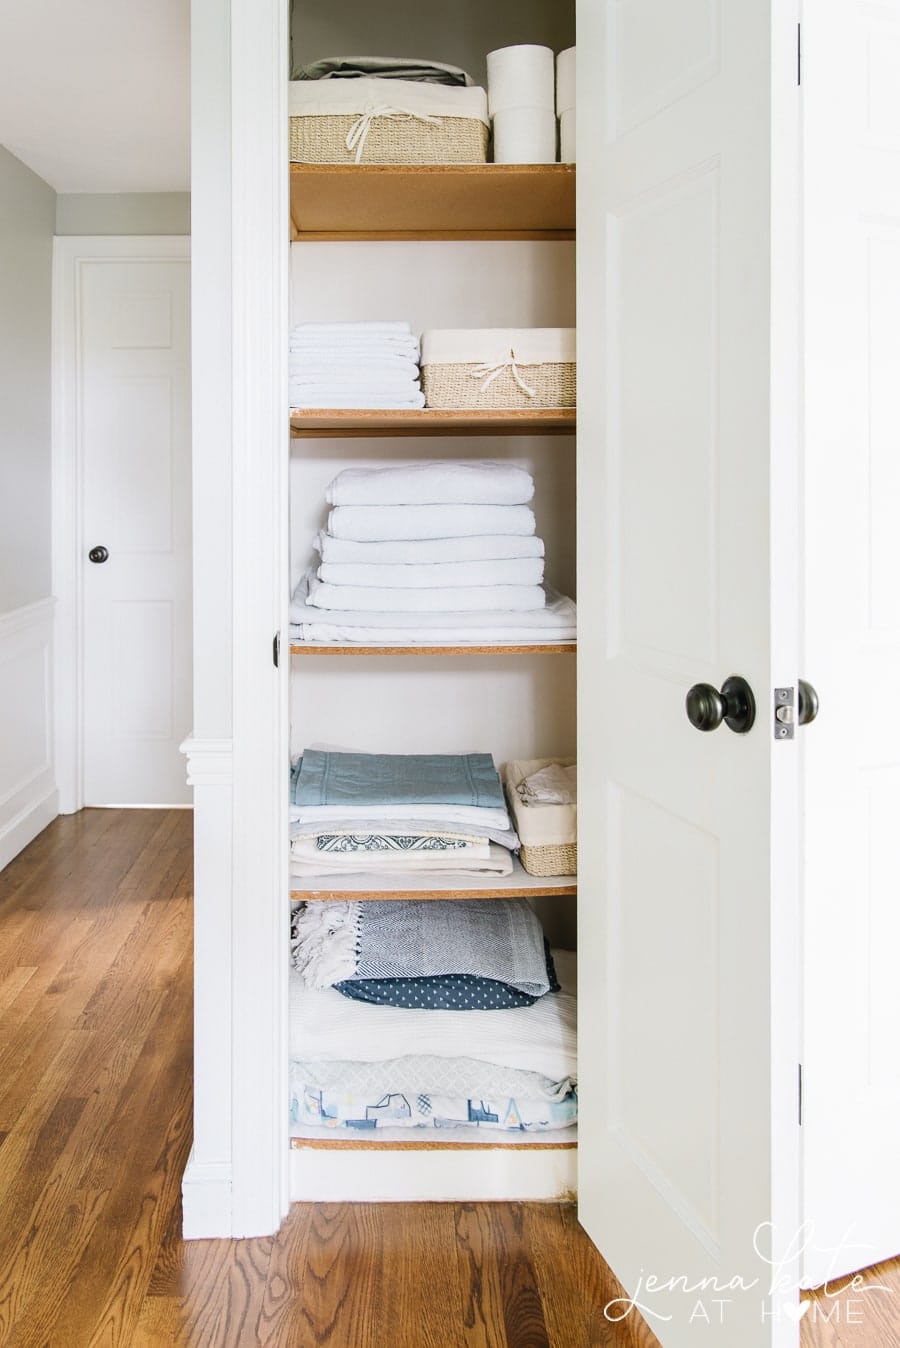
[{"xmin": 488, "ymin": 44, "xmax": 556, "ymax": 164}]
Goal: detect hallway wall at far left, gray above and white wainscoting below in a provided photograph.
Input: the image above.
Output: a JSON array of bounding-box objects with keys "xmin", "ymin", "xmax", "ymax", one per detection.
[{"xmin": 0, "ymin": 147, "xmax": 57, "ymax": 867}]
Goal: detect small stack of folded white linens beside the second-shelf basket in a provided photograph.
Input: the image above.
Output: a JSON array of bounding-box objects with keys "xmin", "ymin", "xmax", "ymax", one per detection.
[{"xmin": 288, "ymin": 322, "xmax": 424, "ymax": 408}]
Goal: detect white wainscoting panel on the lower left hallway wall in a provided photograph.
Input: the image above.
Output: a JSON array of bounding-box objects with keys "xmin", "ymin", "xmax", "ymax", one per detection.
[{"xmin": 0, "ymin": 599, "xmax": 59, "ymax": 868}]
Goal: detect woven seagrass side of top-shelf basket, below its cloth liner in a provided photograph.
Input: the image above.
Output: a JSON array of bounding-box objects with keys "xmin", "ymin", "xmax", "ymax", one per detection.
[{"xmin": 290, "ymin": 113, "xmax": 489, "ymax": 164}]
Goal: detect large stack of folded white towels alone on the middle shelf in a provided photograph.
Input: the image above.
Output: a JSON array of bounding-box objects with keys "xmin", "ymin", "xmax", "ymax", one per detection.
[{"xmin": 291, "ymin": 462, "xmax": 575, "ymax": 646}]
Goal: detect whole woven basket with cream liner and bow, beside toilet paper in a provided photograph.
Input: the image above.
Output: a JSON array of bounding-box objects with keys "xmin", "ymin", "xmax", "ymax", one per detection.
[{"xmin": 288, "ymin": 78, "xmax": 490, "ymax": 164}]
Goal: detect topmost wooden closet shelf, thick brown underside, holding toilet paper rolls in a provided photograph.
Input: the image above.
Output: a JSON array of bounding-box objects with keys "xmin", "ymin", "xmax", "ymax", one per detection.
[{"xmin": 291, "ymin": 164, "xmax": 575, "ymax": 243}]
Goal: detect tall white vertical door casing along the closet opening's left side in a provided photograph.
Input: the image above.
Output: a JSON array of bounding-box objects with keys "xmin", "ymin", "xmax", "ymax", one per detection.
[{"xmin": 230, "ymin": 0, "xmax": 290, "ymax": 1236}]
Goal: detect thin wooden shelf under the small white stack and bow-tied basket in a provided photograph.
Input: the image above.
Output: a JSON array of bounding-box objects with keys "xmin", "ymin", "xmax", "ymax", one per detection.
[{"xmin": 291, "ymin": 407, "xmax": 575, "ymax": 439}]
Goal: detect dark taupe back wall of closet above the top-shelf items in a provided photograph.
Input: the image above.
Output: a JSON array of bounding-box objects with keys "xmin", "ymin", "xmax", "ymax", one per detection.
[{"xmin": 291, "ymin": 0, "xmax": 575, "ymax": 85}]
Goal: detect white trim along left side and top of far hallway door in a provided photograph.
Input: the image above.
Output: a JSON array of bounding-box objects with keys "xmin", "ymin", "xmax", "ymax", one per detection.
[{"xmin": 50, "ymin": 235, "xmax": 190, "ymax": 814}]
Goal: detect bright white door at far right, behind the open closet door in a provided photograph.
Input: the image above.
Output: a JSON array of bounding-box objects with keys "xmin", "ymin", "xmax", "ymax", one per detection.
[{"xmin": 802, "ymin": 0, "xmax": 900, "ymax": 1286}]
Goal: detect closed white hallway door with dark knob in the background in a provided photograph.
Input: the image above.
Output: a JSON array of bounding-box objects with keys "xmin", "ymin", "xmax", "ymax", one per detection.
[{"xmin": 78, "ymin": 257, "xmax": 191, "ymax": 805}]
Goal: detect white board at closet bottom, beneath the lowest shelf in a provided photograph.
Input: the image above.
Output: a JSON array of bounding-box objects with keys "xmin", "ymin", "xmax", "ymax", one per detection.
[{"xmin": 291, "ymin": 1147, "xmax": 578, "ymax": 1202}]
